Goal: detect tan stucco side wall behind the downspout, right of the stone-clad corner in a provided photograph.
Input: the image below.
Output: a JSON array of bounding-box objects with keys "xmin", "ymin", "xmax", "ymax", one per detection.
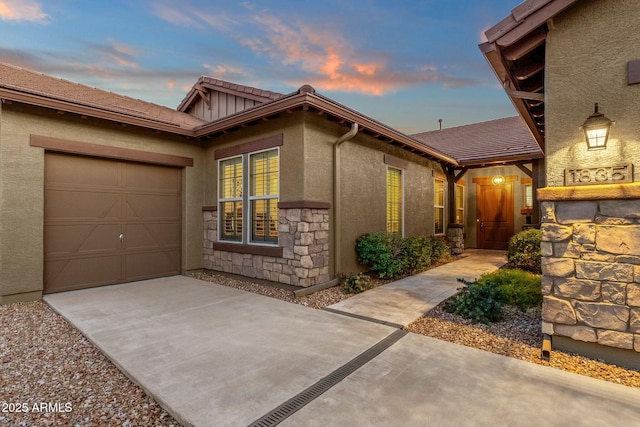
[{"xmin": 305, "ymin": 114, "xmax": 442, "ymax": 274}]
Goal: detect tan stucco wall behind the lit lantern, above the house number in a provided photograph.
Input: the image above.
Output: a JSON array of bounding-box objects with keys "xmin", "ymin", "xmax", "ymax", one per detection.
[{"xmin": 545, "ymin": 0, "xmax": 640, "ymax": 186}]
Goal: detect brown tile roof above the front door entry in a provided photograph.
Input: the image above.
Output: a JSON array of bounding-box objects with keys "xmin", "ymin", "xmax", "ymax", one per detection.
[{"xmin": 410, "ymin": 117, "xmax": 544, "ymax": 166}]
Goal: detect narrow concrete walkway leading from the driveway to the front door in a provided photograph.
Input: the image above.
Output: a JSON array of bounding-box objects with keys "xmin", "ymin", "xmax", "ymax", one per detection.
[{"xmin": 328, "ymin": 249, "xmax": 507, "ymax": 326}]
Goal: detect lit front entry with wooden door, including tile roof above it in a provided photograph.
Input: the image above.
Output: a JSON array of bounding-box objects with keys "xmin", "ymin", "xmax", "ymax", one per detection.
[{"xmin": 412, "ymin": 117, "xmax": 544, "ymax": 250}]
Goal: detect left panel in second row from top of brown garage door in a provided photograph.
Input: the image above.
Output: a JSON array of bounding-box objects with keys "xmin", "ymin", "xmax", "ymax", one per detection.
[{"xmin": 44, "ymin": 189, "xmax": 121, "ymax": 221}]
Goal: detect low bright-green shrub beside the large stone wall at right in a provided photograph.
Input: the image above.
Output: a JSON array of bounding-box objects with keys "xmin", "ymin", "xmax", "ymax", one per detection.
[{"xmin": 478, "ymin": 268, "xmax": 542, "ymax": 310}]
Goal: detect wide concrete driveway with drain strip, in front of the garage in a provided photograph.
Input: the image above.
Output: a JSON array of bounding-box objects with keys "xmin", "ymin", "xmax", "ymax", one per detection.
[{"xmin": 45, "ymin": 276, "xmax": 640, "ymax": 426}]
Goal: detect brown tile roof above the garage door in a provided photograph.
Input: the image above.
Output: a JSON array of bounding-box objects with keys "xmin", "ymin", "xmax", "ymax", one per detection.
[{"xmin": 0, "ymin": 62, "xmax": 204, "ymax": 131}]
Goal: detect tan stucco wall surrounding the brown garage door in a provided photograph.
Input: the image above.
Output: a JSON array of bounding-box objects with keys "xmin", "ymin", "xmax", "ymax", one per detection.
[{"xmin": 0, "ymin": 103, "xmax": 204, "ymax": 302}]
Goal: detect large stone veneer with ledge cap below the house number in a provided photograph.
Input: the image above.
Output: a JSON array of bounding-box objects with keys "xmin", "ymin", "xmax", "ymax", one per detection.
[{"xmin": 538, "ymin": 184, "xmax": 640, "ymax": 366}]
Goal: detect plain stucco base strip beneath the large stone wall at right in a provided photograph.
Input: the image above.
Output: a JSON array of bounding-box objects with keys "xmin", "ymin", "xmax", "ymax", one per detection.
[{"xmin": 551, "ymin": 335, "xmax": 640, "ymax": 371}]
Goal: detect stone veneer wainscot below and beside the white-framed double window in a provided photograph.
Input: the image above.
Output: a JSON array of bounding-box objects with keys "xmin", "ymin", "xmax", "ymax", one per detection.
[{"xmin": 203, "ymin": 202, "xmax": 330, "ymax": 287}]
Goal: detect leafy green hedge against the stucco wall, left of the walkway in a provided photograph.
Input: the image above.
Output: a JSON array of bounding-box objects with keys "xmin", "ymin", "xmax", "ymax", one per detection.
[{"xmin": 356, "ymin": 233, "xmax": 449, "ymax": 278}]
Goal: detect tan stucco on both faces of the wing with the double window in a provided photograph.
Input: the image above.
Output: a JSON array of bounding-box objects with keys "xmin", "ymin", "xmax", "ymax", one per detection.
[{"xmin": 205, "ymin": 112, "xmax": 442, "ymax": 277}]
